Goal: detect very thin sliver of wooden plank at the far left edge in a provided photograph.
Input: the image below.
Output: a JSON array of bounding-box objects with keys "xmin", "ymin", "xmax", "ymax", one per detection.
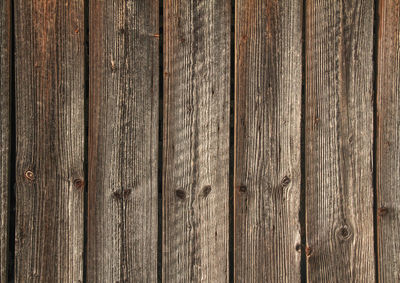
[{"xmin": 0, "ymin": 0, "xmax": 11, "ymax": 282}]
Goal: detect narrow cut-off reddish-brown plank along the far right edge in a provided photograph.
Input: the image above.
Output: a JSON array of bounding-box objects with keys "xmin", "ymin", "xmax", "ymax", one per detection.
[{"xmin": 376, "ymin": 0, "xmax": 400, "ymax": 282}]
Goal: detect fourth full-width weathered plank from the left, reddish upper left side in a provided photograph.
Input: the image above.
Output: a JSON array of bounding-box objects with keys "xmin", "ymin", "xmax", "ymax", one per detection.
[{"xmin": 234, "ymin": 0, "xmax": 302, "ymax": 282}]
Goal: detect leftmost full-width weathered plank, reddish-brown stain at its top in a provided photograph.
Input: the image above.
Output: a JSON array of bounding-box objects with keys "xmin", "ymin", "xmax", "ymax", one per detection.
[{"xmin": 15, "ymin": 0, "xmax": 84, "ymax": 282}]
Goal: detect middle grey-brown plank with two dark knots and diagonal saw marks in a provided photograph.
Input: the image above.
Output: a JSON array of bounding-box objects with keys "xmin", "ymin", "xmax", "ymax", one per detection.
[{"xmin": 162, "ymin": 0, "xmax": 231, "ymax": 282}]
